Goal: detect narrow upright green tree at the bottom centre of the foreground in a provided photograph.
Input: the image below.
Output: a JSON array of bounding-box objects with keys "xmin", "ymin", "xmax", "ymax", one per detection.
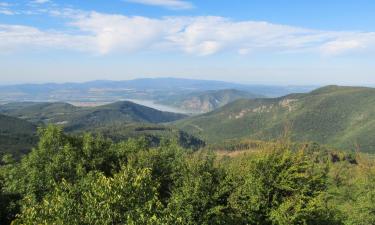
[{"xmin": 166, "ymin": 154, "xmax": 225, "ymax": 224}]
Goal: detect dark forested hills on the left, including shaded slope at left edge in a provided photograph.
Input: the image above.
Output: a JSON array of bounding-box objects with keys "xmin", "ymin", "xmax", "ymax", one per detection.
[{"xmin": 0, "ymin": 101, "xmax": 205, "ymax": 158}]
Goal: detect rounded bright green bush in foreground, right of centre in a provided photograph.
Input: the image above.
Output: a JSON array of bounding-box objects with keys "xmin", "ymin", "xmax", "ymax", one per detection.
[{"xmin": 229, "ymin": 145, "xmax": 335, "ymax": 224}]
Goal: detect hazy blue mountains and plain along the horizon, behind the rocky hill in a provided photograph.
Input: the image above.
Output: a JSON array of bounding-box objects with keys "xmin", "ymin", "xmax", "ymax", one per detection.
[{"xmin": 0, "ymin": 78, "xmax": 314, "ymax": 103}]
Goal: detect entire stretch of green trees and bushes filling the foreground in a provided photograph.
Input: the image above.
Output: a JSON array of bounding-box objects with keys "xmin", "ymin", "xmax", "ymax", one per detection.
[{"xmin": 0, "ymin": 125, "xmax": 375, "ymax": 225}]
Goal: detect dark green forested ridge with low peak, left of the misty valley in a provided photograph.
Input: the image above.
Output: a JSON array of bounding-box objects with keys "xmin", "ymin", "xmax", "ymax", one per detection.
[{"xmin": 0, "ymin": 101, "xmax": 186, "ymax": 131}]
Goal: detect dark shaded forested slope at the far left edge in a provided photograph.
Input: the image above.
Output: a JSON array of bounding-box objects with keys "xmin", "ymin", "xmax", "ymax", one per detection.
[{"xmin": 0, "ymin": 114, "xmax": 37, "ymax": 157}]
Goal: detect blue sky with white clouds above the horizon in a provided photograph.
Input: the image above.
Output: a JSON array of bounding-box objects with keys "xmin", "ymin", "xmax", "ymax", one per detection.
[{"xmin": 0, "ymin": 0, "xmax": 375, "ymax": 85}]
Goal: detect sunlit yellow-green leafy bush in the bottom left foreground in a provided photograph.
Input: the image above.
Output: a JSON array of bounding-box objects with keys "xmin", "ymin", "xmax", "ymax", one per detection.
[{"xmin": 16, "ymin": 167, "xmax": 161, "ymax": 224}]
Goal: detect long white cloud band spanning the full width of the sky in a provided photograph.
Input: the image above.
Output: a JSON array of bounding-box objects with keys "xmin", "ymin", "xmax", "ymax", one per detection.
[{"xmin": 0, "ymin": 9, "xmax": 375, "ymax": 56}]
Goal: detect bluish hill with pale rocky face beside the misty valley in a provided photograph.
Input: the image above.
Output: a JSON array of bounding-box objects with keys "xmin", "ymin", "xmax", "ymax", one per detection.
[{"xmin": 158, "ymin": 89, "xmax": 262, "ymax": 113}]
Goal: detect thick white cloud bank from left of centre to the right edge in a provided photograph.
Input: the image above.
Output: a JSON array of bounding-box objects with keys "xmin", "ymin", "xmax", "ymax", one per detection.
[{"xmin": 72, "ymin": 12, "xmax": 375, "ymax": 55}]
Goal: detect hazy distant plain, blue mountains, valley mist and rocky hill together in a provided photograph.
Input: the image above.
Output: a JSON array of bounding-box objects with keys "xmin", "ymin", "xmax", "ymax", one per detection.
[{"xmin": 0, "ymin": 78, "xmax": 315, "ymax": 113}]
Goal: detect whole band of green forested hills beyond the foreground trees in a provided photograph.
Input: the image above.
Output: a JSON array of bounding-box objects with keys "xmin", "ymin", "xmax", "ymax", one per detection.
[{"xmin": 0, "ymin": 83, "xmax": 375, "ymax": 152}]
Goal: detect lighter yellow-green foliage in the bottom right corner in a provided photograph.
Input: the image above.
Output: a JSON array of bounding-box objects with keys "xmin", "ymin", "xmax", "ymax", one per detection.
[{"xmin": 329, "ymin": 156, "xmax": 375, "ymax": 225}]
